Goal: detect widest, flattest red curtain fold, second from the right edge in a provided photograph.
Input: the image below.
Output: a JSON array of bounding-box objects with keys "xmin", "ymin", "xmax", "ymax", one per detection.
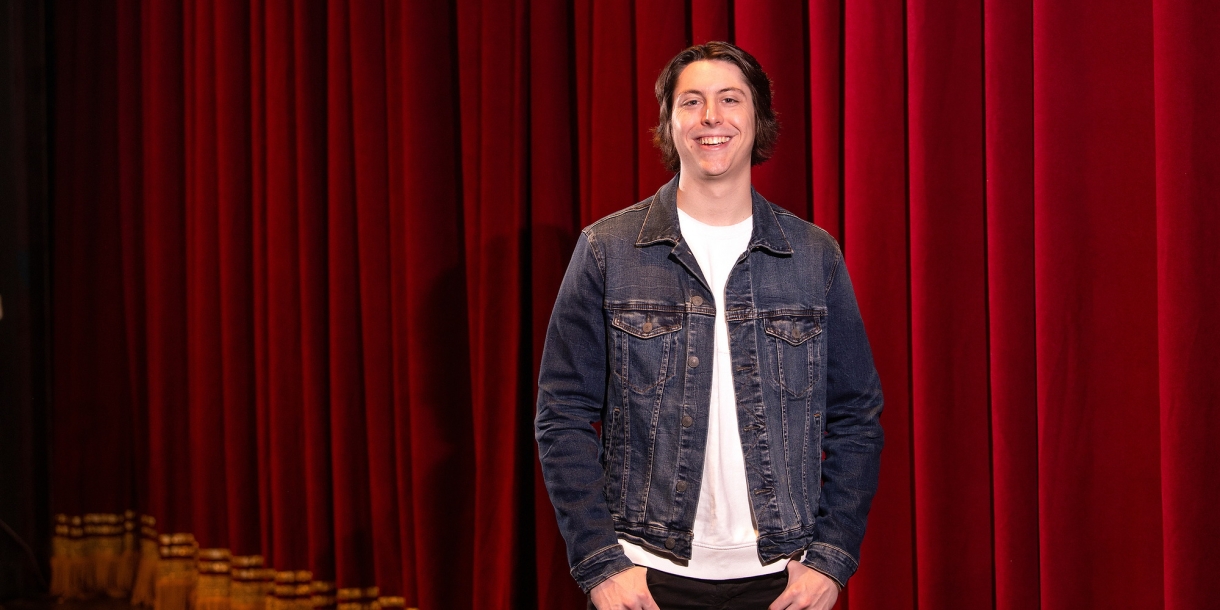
[{"xmin": 1033, "ymin": 1, "xmax": 1164, "ymax": 609}]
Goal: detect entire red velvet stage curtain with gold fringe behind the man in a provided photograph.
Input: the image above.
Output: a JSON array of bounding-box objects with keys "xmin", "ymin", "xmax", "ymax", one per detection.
[{"xmin": 52, "ymin": 0, "xmax": 1220, "ymax": 610}]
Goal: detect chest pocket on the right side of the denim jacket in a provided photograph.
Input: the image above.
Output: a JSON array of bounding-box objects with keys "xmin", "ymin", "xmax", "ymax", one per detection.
[{"xmin": 763, "ymin": 310, "xmax": 826, "ymax": 398}]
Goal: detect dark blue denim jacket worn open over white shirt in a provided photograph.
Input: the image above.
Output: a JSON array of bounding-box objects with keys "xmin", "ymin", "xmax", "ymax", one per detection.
[{"xmin": 534, "ymin": 177, "xmax": 883, "ymax": 592}]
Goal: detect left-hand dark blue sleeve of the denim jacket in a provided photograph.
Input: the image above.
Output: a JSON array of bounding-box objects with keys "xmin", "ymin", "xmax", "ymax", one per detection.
[{"xmin": 534, "ymin": 233, "xmax": 633, "ymax": 593}]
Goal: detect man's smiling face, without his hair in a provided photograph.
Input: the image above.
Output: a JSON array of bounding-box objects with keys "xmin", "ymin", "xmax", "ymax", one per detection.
[{"xmin": 670, "ymin": 60, "xmax": 754, "ymax": 181}]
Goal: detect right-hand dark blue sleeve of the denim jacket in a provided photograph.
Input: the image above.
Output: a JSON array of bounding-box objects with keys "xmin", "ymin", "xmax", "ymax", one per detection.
[{"xmin": 802, "ymin": 250, "xmax": 885, "ymax": 587}]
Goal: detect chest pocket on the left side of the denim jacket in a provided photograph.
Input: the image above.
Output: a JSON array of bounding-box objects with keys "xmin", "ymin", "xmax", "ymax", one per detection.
[{"xmin": 610, "ymin": 310, "xmax": 682, "ymax": 394}]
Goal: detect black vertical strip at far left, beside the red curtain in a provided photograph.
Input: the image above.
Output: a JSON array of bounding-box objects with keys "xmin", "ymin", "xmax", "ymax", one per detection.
[{"xmin": 0, "ymin": 0, "xmax": 50, "ymax": 600}]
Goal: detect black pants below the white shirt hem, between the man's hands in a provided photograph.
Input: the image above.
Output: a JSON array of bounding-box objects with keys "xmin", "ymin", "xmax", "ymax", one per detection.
[{"xmin": 588, "ymin": 570, "xmax": 788, "ymax": 610}]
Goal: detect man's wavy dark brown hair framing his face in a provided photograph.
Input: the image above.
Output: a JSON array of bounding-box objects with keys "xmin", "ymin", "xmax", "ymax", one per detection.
[{"xmin": 653, "ymin": 40, "xmax": 780, "ymax": 172}]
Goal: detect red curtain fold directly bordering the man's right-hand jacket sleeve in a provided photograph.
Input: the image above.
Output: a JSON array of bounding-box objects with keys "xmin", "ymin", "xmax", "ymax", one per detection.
[{"xmin": 839, "ymin": 0, "xmax": 912, "ymax": 609}]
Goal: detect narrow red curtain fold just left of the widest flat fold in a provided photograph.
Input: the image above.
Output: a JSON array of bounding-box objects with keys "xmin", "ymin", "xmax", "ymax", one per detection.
[{"xmin": 983, "ymin": 2, "xmax": 1041, "ymax": 609}]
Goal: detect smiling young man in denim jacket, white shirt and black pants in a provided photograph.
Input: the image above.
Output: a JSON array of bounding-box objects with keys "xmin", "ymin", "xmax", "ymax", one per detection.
[{"xmin": 536, "ymin": 43, "xmax": 882, "ymax": 610}]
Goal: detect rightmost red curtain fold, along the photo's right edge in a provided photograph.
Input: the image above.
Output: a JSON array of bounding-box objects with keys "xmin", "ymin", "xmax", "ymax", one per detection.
[{"xmin": 1153, "ymin": 1, "xmax": 1220, "ymax": 608}]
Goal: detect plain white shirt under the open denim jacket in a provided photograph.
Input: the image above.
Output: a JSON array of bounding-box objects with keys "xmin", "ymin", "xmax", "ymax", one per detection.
[{"xmin": 619, "ymin": 210, "xmax": 787, "ymax": 581}]
